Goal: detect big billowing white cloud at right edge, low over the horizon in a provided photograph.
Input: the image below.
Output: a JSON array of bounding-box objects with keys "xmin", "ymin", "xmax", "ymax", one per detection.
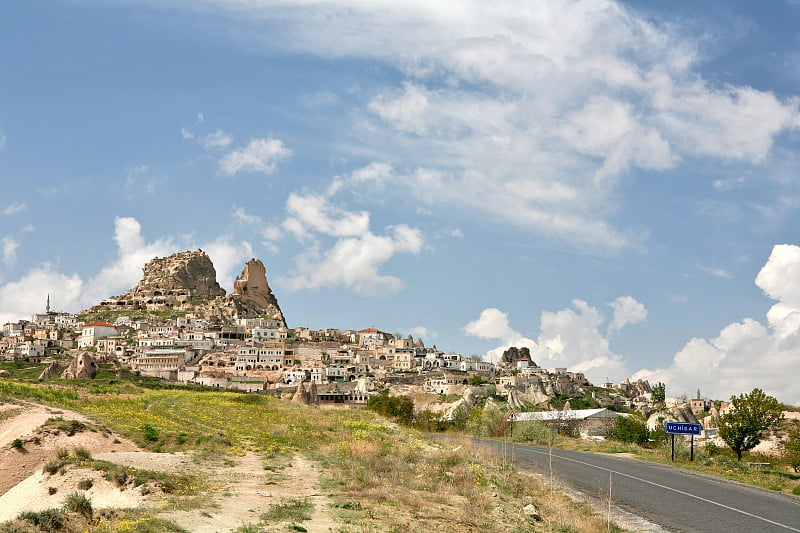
[{"xmin": 634, "ymin": 244, "xmax": 800, "ymax": 404}]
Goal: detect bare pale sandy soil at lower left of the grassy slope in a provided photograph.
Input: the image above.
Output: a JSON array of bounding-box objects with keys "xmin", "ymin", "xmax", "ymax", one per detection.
[{"xmin": 0, "ymin": 404, "xmax": 337, "ymax": 533}]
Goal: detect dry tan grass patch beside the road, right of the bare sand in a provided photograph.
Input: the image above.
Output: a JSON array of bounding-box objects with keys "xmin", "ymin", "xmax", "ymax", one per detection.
[{"xmin": 321, "ymin": 432, "xmax": 619, "ymax": 533}]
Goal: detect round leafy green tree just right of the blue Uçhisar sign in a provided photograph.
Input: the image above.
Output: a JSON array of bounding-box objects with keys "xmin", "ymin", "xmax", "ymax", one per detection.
[{"xmin": 719, "ymin": 389, "xmax": 783, "ymax": 461}]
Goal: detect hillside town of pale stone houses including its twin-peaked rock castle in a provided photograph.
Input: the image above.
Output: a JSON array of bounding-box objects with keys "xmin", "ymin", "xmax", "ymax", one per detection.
[{"xmin": 0, "ymin": 250, "xmax": 776, "ymax": 444}]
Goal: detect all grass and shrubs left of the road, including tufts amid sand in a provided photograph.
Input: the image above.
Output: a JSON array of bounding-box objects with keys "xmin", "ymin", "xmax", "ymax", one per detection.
[{"xmin": 0, "ymin": 370, "xmax": 620, "ymax": 533}]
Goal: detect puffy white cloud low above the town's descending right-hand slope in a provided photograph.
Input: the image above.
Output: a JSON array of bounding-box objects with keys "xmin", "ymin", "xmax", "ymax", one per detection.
[{"xmin": 464, "ymin": 296, "xmax": 636, "ymax": 381}]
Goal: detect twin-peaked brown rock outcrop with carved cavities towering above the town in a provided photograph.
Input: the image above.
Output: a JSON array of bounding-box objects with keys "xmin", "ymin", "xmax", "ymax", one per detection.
[{"xmin": 85, "ymin": 249, "xmax": 286, "ymax": 326}]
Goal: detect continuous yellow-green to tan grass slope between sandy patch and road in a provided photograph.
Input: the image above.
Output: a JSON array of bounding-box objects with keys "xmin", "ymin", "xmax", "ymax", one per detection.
[{"xmin": 0, "ymin": 366, "xmax": 616, "ymax": 532}]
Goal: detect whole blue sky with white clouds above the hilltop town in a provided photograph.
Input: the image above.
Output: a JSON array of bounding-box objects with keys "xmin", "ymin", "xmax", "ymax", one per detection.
[{"xmin": 0, "ymin": 0, "xmax": 800, "ymax": 402}]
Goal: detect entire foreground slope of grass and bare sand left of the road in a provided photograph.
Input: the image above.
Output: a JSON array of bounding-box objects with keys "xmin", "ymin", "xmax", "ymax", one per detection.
[{"xmin": 0, "ymin": 370, "xmax": 624, "ymax": 533}]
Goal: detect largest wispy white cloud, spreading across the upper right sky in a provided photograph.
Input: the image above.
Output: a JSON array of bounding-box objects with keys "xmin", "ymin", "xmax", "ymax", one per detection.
[{"xmin": 147, "ymin": 0, "xmax": 798, "ymax": 253}]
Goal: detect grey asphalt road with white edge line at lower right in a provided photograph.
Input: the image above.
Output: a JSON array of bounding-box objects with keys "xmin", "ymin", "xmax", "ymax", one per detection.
[{"xmin": 450, "ymin": 439, "xmax": 800, "ymax": 533}]
